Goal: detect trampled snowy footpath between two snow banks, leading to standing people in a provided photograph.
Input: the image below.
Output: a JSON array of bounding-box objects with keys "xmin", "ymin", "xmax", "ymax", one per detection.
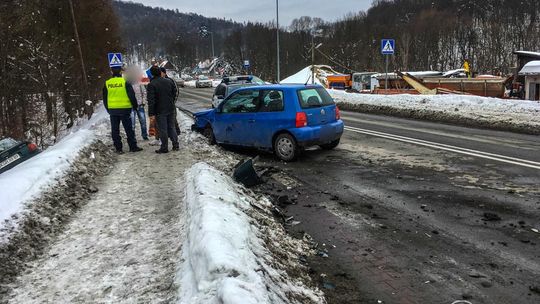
[{"xmin": 8, "ymin": 144, "xmax": 188, "ymax": 303}]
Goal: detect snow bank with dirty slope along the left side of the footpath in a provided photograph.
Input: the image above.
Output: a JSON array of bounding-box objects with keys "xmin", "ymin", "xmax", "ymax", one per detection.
[{"xmin": 0, "ymin": 109, "xmax": 114, "ymax": 296}]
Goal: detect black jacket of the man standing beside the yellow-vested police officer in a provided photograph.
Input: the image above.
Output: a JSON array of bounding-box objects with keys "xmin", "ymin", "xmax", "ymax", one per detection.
[{"xmin": 146, "ymin": 77, "xmax": 176, "ymax": 116}]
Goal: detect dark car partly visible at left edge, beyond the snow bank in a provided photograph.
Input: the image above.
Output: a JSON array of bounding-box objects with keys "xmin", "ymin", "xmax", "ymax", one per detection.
[{"xmin": 0, "ymin": 137, "xmax": 40, "ymax": 173}]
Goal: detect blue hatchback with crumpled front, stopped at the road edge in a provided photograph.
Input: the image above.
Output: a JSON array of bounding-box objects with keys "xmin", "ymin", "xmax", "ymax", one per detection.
[{"xmin": 193, "ymin": 84, "xmax": 343, "ymax": 161}]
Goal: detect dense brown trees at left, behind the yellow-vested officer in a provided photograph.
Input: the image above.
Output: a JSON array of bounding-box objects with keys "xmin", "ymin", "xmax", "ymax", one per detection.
[{"xmin": 0, "ymin": 0, "xmax": 122, "ymax": 146}]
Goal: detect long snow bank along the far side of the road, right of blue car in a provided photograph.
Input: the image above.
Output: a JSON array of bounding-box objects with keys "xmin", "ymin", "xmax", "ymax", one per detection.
[{"xmin": 328, "ymin": 90, "xmax": 540, "ymax": 134}]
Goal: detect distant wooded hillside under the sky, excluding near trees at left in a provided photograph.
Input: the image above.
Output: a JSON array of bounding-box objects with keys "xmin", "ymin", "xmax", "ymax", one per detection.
[{"xmin": 115, "ymin": 0, "xmax": 540, "ymax": 80}]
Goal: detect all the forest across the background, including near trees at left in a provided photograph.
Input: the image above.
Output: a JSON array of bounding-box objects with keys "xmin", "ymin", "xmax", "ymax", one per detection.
[{"xmin": 0, "ymin": 0, "xmax": 540, "ymax": 145}]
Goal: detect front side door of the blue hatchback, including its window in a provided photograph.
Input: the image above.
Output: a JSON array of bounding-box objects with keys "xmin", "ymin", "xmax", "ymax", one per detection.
[{"xmin": 214, "ymin": 90, "xmax": 259, "ymax": 146}]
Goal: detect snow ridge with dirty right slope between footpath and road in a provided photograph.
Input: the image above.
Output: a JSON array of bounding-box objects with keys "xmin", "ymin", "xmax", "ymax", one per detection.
[{"xmin": 178, "ymin": 163, "xmax": 325, "ymax": 304}]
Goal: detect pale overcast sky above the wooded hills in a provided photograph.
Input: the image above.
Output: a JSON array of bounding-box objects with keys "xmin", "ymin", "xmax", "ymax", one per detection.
[{"xmin": 124, "ymin": 0, "xmax": 372, "ymax": 26}]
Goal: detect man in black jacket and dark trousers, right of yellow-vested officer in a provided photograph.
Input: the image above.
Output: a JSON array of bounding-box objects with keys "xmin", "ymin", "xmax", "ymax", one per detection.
[{"xmin": 146, "ymin": 66, "xmax": 179, "ymax": 153}]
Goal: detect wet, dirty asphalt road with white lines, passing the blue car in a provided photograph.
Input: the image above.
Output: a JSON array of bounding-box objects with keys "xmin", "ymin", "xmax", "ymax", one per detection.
[{"xmin": 180, "ymin": 89, "xmax": 540, "ymax": 303}]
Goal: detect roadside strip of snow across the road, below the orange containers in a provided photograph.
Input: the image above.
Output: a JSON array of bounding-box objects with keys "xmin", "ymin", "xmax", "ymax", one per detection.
[{"xmin": 328, "ymin": 90, "xmax": 540, "ymax": 129}]
